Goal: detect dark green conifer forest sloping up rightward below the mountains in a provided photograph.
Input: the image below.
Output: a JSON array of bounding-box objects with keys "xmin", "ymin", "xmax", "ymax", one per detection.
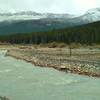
[{"xmin": 0, "ymin": 22, "xmax": 100, "ymax": 44}]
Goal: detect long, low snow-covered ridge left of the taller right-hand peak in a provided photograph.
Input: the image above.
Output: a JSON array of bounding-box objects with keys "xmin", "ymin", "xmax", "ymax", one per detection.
[{"xmin": 0, "ymin": 11, "xmax": 75, "ymax": 21}]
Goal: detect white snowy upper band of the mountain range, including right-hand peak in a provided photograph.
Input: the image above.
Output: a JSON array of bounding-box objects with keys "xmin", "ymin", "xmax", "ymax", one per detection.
[{"xmin": 0, "ymin": 8, "xmax": 100, "ymax": 22}]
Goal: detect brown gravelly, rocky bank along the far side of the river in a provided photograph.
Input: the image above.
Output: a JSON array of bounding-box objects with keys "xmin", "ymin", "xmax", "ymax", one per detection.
[{"xmin": 6, "ymin": 48, "xmax": 100, "ymax": 77}]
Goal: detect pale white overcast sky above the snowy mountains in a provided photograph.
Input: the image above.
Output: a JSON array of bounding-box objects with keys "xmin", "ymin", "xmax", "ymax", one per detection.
[{"xmin": 0, "ymin": 0, "xmax": 100, "ymax": 14}]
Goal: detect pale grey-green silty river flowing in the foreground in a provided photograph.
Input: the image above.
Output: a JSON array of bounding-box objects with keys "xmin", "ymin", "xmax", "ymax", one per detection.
[{"xmin": 0, "ymin": 51, "xmax": 100, "ymax": 100}]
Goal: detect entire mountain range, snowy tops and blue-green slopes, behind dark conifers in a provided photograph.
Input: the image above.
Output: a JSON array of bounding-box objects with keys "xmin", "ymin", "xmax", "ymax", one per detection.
[{"xmin": 0, "ymin": 8, "xmax": 100, "ymax": 34}]
